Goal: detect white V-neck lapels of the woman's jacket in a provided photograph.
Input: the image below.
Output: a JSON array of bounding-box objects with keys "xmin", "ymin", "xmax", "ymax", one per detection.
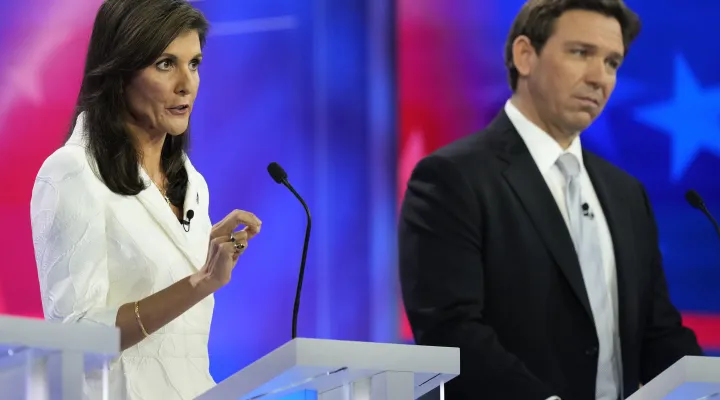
[{"xmin": 137, "ymin": 163, "xmax": 207, "ymax": 270}]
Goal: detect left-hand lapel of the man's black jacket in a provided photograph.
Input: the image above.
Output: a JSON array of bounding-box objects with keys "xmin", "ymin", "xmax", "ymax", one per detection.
[{"xmin": 488, "ymin": 111, "xmax": 592, "ymax": 318}]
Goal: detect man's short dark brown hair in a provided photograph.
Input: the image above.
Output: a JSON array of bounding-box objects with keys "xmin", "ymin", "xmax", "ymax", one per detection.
[{"xmin": 505, "ymin": 0, "xmax": 640, "ymax": 92}]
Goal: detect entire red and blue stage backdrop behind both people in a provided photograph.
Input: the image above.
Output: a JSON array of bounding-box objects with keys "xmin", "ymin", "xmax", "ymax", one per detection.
[{"xmin": 0, "ymin": 0, "xmax": 720, "ymax": 386}]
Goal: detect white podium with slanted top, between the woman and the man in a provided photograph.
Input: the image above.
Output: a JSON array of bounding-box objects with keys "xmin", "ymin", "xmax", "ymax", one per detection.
[{"xmin": 197, "ymin": 338, "xmax": 460, "ymax": 400}]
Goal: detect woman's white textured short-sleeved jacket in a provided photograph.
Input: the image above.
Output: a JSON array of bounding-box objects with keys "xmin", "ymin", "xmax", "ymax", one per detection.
[{"xmin": 30, "ymin": 114, "xmax": 215, "ymax": 400}]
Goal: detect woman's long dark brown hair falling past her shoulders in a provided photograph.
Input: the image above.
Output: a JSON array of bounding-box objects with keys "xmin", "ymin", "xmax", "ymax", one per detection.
[{"xmin": 68, "ymin": 0, "xmax": 209, "ymax": 205}]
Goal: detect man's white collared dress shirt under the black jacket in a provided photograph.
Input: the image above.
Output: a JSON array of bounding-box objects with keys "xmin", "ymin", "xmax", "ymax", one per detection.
[{"xmin": 505, "ymin": 100, "xmax": 621, "ymax": 400}]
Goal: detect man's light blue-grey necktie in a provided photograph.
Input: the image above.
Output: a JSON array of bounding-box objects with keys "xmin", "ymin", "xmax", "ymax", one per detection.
[{"xmin": 557, "ymin": 153, "xmax": 620, "ymax": 400}]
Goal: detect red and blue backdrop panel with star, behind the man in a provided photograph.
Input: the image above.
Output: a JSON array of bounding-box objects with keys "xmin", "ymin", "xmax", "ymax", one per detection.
[{"xmin": 398, "ymin": 0, "xmax": 720, "ymax": 354}]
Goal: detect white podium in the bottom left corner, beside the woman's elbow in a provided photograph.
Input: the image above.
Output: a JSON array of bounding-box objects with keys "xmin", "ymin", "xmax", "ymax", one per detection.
[{"xmin": 0, "ymin": 316, "xmax": 120, "ymax": 400}]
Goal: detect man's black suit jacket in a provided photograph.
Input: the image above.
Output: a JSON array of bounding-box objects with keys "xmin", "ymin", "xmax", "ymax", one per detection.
[{"xmin": 399, "ymin": 112, "xmax": 702, "ymax": 400}]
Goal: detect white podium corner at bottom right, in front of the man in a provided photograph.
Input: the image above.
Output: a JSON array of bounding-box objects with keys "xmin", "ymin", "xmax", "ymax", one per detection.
[{"xmin": 628, "ymin": 356, "xmax": 720, "ymax": 400}]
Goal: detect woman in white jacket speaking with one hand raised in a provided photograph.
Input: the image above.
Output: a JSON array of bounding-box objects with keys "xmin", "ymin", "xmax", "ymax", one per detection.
[{"xmin": 31, "ymin": 0, "xmax": 260, "ymax": 400}]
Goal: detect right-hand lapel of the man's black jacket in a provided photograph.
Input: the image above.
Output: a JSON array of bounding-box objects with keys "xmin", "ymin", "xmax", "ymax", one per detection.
[{"xmin": 583, "ymin": 152, "xmax": 639, "ymax": 376}]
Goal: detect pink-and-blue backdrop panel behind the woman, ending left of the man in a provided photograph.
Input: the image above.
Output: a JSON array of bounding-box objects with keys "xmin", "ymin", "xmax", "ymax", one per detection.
[{"xmin": 0, "ymin": 0, "xmax": 398, "ymax": 380}]
